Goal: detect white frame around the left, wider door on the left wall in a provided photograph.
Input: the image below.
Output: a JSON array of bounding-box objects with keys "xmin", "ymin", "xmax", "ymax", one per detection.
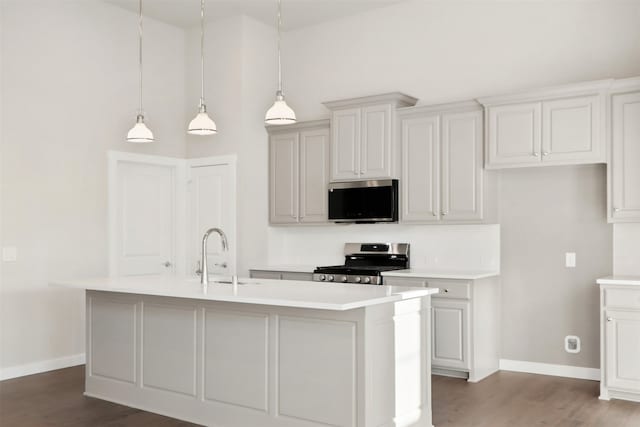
[{"xmin": 107, "ymin": 150, "xmax": 186, "ymax": 277}]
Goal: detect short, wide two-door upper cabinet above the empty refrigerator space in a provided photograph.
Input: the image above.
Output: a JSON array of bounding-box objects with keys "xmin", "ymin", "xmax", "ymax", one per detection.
[{"xmin": 479, "ymin": 80, "xmax": 611, "ymax": 169}]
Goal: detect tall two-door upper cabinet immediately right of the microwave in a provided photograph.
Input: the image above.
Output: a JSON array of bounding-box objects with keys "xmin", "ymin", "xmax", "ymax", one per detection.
[{"xmin": 398, "ymin": 102, "xmax": 484, "ymax": 223}]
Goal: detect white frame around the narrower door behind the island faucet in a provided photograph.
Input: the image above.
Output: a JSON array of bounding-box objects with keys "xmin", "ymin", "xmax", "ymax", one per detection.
[{"xmin": 185, "ymin": 154, "xmax": 238, "ymax": 275}]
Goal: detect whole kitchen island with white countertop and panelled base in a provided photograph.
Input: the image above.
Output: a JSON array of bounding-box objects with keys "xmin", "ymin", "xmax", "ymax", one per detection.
[{"xmin": 54, "ymin": 276, "xmax": 437, "ymax": 427}]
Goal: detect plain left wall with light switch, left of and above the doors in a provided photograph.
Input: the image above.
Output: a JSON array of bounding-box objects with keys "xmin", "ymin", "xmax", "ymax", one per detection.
[{"xmin": 0, "ymin": 0, "xmax": 186, "ymax": 377}]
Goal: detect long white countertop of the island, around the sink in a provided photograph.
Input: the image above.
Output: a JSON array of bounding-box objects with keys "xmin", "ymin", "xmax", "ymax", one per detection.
[{"xmin": 51, "ymin": 276, "xmax": 438, "ymax": 311}]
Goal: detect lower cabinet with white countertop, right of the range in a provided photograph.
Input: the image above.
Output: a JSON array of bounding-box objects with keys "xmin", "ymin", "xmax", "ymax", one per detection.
[{"xmin": 384, "ymin": 275, "xmax": 500, "ymax": 382}]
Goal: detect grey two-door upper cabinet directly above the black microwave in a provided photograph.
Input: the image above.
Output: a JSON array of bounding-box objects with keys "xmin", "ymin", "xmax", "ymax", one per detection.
[{"xmin": 324, "ymin": 93, "xmax": 417, "ymax": 181}]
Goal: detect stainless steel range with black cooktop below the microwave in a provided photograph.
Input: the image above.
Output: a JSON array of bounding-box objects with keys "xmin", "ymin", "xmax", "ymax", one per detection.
[{"xmin": 313, "ymin": 243, "xmax": 409, "ymax": 285}]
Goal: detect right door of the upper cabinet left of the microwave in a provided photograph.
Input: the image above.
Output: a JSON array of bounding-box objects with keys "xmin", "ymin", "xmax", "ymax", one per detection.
[{"xmin": 300, "ymin": 129, "xmax": 329, "ymax": 222}]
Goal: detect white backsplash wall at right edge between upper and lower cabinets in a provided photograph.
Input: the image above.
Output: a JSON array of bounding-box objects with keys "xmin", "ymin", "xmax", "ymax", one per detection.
[{"xmin": 613, "ymin": 224, "xmax": 640, "ymax": 275}]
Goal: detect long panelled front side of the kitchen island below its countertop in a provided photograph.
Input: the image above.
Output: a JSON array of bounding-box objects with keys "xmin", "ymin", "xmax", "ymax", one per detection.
[{"xmin": 86, "ymin": 291, "xmax": 367, "ymax": 427}]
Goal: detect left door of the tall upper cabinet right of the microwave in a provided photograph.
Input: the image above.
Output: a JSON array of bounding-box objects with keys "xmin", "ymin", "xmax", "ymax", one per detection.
[{"xmin": 400, "ymin": 115, "xmax": 440, "ymax": 222}]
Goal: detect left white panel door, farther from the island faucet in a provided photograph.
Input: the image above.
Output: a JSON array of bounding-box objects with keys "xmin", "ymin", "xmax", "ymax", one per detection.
[{"xmin": 115, "ymin": 162, "xmax": 176, "ymax": 276}]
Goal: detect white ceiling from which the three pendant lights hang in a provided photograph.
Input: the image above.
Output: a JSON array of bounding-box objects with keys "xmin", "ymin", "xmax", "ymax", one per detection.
[{"xmin": 104, "ymin": 0, "xmax": 405, "ymax": 31}]
